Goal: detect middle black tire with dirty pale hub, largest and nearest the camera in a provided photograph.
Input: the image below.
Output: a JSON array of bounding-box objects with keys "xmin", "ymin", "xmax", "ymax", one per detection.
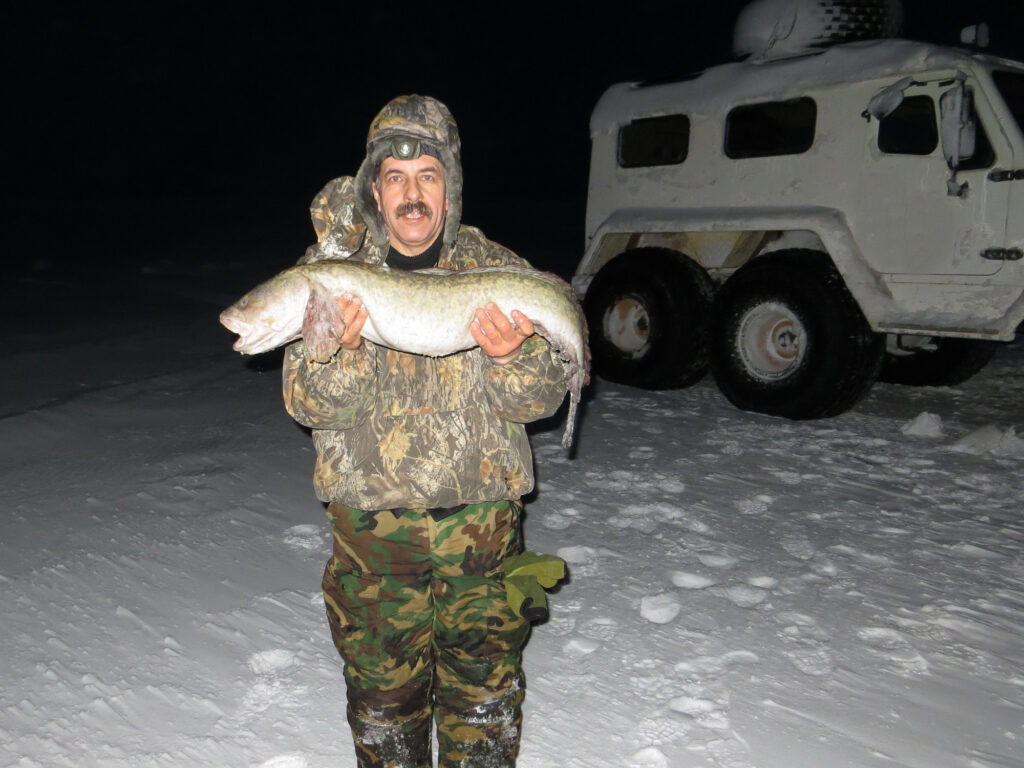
[{"xmin": 709, "ymin": 249, "xmax": 885, "ymax": 419}]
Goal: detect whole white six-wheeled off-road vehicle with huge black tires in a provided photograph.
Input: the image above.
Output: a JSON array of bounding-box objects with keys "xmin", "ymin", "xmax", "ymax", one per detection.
[{"xmin": 573, "ymin": 2, "xmax": 1024, "ymax": 419}]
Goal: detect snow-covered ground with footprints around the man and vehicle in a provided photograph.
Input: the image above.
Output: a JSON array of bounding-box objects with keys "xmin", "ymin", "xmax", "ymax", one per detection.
[{"xmin": 0, "ymin": 249, "xmax": 1024, "ymax": 768}]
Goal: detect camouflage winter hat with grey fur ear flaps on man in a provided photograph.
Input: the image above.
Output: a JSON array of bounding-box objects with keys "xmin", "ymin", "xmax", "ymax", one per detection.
[{"xmin": 355, "ymin": 94, "xmax": 462, "ymax": 246}]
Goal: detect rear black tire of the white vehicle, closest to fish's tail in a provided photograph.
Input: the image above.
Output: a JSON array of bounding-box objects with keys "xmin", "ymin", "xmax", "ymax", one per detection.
[{"xmin": 584, "ymin": 248, "xmax": 715, "ymax": 389}]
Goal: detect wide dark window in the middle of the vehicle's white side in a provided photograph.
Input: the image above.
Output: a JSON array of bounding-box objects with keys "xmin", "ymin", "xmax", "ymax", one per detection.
[{"xmin": 725, "ymin": 96, "xmax": 818, "ymax": 159}]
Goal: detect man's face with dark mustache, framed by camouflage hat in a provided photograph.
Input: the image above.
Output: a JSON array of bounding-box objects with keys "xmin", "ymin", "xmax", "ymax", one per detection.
[{"xmin": 373, "ymin": 155, "xmax": 447, "ymax": 256}]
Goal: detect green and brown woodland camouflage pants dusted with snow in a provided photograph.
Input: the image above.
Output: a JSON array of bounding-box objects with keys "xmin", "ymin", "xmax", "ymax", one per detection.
[{"xmin": 324, "ymin": 502, "xmax": 529, "ymax": 768}]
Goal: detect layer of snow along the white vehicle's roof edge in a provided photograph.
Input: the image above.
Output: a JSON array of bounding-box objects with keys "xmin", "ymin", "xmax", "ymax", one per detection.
[{"xmin": 590, "ymin": 39, "xmax": 1024, "ymax": 135}]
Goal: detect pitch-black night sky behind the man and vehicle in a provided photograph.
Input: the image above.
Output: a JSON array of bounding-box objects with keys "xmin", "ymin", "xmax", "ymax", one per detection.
[{"xmin": 8, "ymin": 0, "xmax": 1024, "ymax": 276}]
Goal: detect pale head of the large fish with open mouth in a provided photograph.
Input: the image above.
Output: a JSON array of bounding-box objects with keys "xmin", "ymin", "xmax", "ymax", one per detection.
[{"xmin": 220, "ymin": 271, "xmax": 309, "ymax": 354}]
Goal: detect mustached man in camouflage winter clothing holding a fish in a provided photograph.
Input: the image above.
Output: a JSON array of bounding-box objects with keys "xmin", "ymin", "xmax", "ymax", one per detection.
[{"xmin": 284, "ymin": 95, "xmax": 565, "ymax": 768}]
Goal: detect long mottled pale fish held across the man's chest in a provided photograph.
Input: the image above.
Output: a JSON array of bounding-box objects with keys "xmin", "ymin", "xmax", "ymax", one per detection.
[{"xmin": 220, "ymin": 260, "xmax": 590, "ymax": 447}]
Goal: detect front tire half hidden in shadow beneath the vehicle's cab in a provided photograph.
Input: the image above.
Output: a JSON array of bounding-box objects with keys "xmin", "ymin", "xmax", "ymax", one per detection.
[{"xmin": 879, "ymin": 337, "xmax": 998, "ymax": 387}]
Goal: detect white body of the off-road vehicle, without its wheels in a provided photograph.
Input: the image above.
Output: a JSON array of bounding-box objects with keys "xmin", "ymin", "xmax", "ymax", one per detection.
[{"xmin": 573, "ymin": 39, "xmax": 1024, "ymax": 417}]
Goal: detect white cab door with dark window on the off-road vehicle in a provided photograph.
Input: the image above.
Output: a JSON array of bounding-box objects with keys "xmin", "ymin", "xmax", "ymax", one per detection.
[{"xmin": 859, "ymin": 73, "xmax": 1014, "ymax": 282}]
